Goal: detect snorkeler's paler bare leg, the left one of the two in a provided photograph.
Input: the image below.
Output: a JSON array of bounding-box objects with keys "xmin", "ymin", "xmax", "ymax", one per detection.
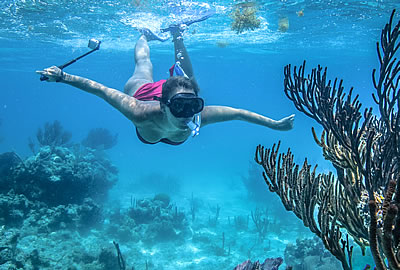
[{"xmin": 124, "ymin": 35, "xmax": 153, "ymax": 96}]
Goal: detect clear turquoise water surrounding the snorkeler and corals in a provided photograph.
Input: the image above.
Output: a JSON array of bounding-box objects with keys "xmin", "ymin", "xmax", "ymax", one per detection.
[{"xmin": 0, "ymin": 0, "xmax": 400, "ymax": 269}]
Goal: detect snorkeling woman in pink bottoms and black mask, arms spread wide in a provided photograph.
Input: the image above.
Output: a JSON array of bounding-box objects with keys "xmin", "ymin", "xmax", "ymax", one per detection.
[{"xmin": 37, "ymin": 20, "xmax": 294, "ymax": 145}]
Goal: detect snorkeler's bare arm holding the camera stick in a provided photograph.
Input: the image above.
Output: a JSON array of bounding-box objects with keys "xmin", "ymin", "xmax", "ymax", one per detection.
[{"xmin": 36, "ymin": 66, "xmax": 142, "ymax": 122}]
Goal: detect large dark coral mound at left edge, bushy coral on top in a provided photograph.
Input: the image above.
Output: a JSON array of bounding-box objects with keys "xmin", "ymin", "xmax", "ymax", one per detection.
[{"xmin": 0, "ymin": 121, "xmax": 118, "ymax": 221}]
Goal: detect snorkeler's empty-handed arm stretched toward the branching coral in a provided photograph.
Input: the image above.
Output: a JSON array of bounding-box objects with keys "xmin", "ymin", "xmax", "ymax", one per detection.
[{"xmin": 201, "ymin": 106, "xmax": 294, "ymax": 130}]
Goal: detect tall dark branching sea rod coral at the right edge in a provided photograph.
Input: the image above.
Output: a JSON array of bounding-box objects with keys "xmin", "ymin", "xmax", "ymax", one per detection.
[{"xmin": 255, "ymin": 8, "xmax": 400, "ymax": 270}]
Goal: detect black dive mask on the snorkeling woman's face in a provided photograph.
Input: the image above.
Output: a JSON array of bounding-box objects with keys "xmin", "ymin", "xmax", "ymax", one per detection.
[{"xmin": 165, "ymin": 93, "xmax": 204, "ymax": 118}]
